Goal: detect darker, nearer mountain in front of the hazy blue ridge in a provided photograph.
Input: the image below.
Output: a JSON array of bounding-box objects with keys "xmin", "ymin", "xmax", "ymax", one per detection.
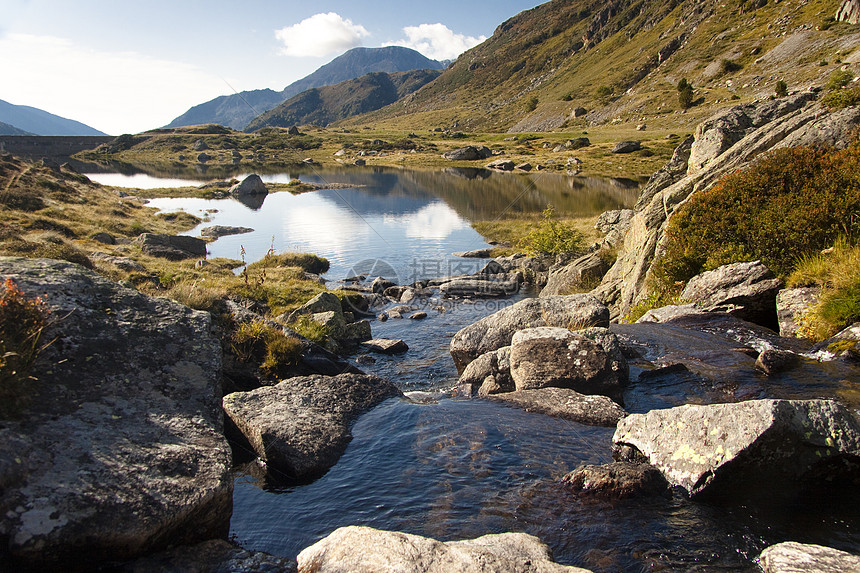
[{"xmin": 245, "ymin": 70, "xmax": 441, "ymax": 131}]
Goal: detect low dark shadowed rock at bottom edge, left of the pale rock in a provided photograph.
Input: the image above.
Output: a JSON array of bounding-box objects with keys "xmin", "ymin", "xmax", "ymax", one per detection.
[{"xmin": 120, "ymin": 539, "xmax": 297, "ymax": 573}]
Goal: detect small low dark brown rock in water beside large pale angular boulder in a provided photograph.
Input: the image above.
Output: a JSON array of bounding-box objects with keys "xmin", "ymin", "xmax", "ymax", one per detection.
[{"xmin": 562, "ymin": 462, "xmax": 669, "ymax": 499}]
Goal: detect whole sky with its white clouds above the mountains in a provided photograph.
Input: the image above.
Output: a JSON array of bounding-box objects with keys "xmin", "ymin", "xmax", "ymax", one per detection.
[{"xmin": 0, "ymin": 0, "xmax": 542, "ymax": 135}]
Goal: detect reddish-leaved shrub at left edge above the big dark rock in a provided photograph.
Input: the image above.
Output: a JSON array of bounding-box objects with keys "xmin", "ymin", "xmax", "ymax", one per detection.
[{"xmin": 0, "ymin": 279, "xmax": 49, "ymax": 418}]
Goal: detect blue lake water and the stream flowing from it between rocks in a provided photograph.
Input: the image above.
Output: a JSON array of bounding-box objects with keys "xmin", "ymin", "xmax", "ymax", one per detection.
[{"xmin": 85, "ymin": 163, "xmax": 860, "ymax": 572}]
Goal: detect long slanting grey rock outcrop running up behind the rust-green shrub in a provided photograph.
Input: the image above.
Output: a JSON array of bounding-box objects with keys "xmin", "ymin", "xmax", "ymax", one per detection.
[{"xmin": 593, "ymin": 98, "xmax": 860, "ymax": 318}]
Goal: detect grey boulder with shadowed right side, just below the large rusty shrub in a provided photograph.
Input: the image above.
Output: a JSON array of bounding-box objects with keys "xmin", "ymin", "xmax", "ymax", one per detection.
[{"xmin": 681, "ymin": 261, "xmax": 782, "ymax": 330}]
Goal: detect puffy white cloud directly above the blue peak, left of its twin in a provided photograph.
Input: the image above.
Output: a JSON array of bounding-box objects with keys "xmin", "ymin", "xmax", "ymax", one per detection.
[{"xmin": 275, "ymin": 12, "xmax": 370, "ymax": 57}]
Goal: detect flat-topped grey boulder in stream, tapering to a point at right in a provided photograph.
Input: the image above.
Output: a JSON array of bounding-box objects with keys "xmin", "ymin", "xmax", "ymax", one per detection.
[{"xmin": 223, "ymin": 374, "xmax": 403, "ymax": 482}]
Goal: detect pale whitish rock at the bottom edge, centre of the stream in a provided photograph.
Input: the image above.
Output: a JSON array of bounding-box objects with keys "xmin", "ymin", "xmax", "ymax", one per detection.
[{"xmin": 297, "ymin": 526, "xmax": 587, "ymax": 573}]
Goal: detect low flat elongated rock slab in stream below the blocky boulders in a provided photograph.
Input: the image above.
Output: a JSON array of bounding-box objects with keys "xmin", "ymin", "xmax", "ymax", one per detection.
[{"xmin": 488, "ymin": 388, "xmax": 627, "ymax": 428}]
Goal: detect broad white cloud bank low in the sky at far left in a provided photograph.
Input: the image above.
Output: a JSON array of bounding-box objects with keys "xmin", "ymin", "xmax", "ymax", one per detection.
[{"xmin": 0, "ymin": 34, "xmax": 227, "ymax": 135}]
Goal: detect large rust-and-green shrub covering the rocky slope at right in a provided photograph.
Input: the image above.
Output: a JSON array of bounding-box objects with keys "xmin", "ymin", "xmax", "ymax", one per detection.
[{"xmin": 654, "ymin": 142, "xmax": 860, "ymax": 286}]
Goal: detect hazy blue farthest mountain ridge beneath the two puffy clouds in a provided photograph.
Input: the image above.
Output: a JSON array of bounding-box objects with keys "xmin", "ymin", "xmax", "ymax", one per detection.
[{"xmin": 165, "ymin": 46, "xmax": 445, "ymax": 130}]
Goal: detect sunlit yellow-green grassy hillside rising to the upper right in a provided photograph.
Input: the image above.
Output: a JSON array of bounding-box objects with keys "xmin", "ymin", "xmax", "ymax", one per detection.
[{"xmin": 343, "ymin": 0, "xmax": 860, "ymax": 132}]
